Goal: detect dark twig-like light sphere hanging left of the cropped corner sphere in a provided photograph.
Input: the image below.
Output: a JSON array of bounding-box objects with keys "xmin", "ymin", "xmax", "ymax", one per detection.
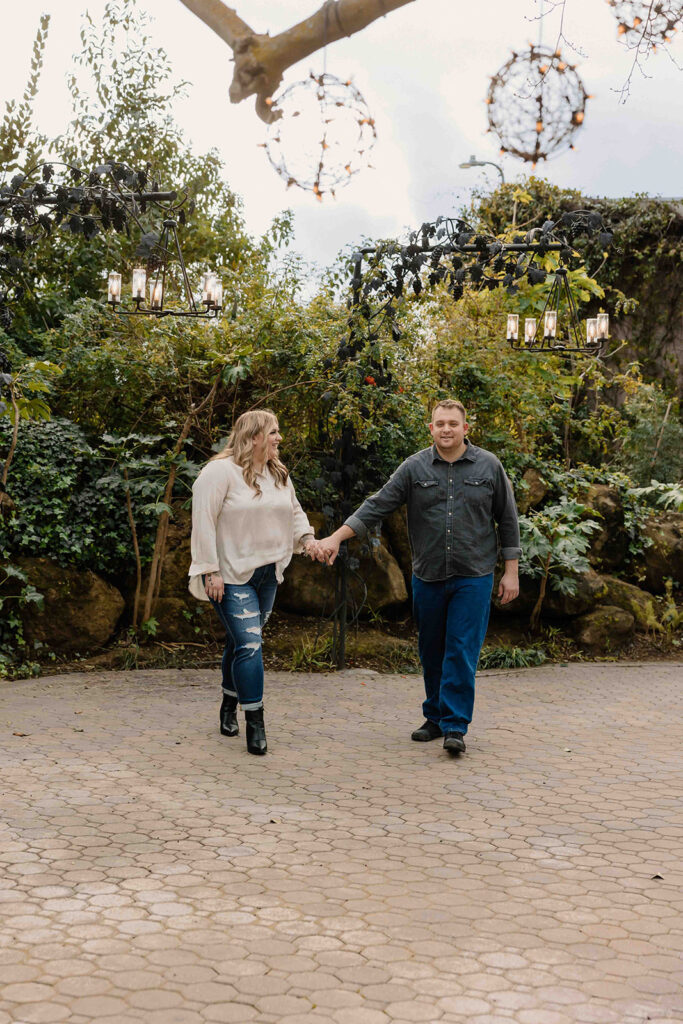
[{"xmin": 486, "ymin": 46, "xmax": 590, "ymax": 164}]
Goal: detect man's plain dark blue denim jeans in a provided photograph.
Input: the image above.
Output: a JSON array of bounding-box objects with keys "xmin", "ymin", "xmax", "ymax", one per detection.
[{"xmin": 413, "ymin": 572, "xmax": 494, "ymax": 733}]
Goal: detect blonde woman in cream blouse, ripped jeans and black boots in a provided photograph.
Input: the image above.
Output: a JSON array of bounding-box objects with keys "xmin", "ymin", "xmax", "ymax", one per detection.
[{"xmin": 189, "ymin": 410, "xmax": 323, "ymax": 754}]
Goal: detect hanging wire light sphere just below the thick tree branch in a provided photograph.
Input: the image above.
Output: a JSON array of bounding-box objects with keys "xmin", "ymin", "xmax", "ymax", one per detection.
[{"xmin": 263, "ymin": 72, "xmax": 377, "ymax": 200}]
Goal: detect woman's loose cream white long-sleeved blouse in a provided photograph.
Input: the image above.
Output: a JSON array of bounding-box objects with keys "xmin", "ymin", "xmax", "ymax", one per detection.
[{"xmin": 189, "ymin": 457, "xmax": 314, "ymax": 601}]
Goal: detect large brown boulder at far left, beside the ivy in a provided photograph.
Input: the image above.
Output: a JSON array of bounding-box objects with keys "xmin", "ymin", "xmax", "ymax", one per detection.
[{"xmin": 14, "ymin": 558, "xmax": 125, "ymax": 654}]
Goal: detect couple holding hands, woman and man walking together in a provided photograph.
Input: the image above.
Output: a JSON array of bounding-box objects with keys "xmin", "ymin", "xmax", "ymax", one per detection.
[{"xmin": 189, "ymin": 398, "xmax": 521, "ymax": 754}]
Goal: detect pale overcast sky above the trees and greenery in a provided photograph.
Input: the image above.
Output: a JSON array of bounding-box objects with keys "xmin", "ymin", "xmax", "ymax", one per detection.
[{"xmin": 0, "ymin": 0, "xmax": 683, "ymax": 263}]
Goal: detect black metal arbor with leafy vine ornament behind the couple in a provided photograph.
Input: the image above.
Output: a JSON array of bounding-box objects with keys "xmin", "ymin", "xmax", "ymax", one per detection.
[{"xmin": 330, "ymin": 210, "xmax": 612, "ymax": 669}]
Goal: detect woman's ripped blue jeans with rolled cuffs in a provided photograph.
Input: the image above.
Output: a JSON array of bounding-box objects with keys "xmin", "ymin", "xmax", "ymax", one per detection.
[{"xmin": 205, "ymin": 564, "xmax": 278, "ymax": 711}]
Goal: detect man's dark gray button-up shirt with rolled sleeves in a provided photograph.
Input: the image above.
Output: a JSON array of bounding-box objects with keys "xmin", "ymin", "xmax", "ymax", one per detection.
[{"xmin": 345, "ymin": 439, "xmax": 521, "ymax": 582}]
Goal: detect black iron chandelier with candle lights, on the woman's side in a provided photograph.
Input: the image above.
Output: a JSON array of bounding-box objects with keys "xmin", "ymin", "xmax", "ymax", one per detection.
[{"xmin": 106, "ymin": 217, "xmax": 223, "ymax": 319}]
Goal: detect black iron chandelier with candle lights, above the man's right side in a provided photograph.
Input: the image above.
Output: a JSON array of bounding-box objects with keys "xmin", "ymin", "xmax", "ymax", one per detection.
[{"xmin": 507, "ymin": 266, "xmax": 609, "ymax": 355}]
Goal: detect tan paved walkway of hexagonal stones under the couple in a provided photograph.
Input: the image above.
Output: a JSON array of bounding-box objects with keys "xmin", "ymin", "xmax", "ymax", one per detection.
[{"xmin": 0, "ymin": 664, "xmax": 683, "ymax": 1024}]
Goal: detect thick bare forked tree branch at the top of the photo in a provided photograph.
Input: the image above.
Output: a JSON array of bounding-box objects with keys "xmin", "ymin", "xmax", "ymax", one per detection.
[{"xmin": 180, "ymin": 0, "xmax": 414, "ymax": 122}]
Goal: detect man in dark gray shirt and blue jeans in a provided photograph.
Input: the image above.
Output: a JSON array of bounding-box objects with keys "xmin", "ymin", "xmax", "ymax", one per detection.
[{"xmin": 321, "ymin": 398, "xmax": 521, "ymax": 754}]
